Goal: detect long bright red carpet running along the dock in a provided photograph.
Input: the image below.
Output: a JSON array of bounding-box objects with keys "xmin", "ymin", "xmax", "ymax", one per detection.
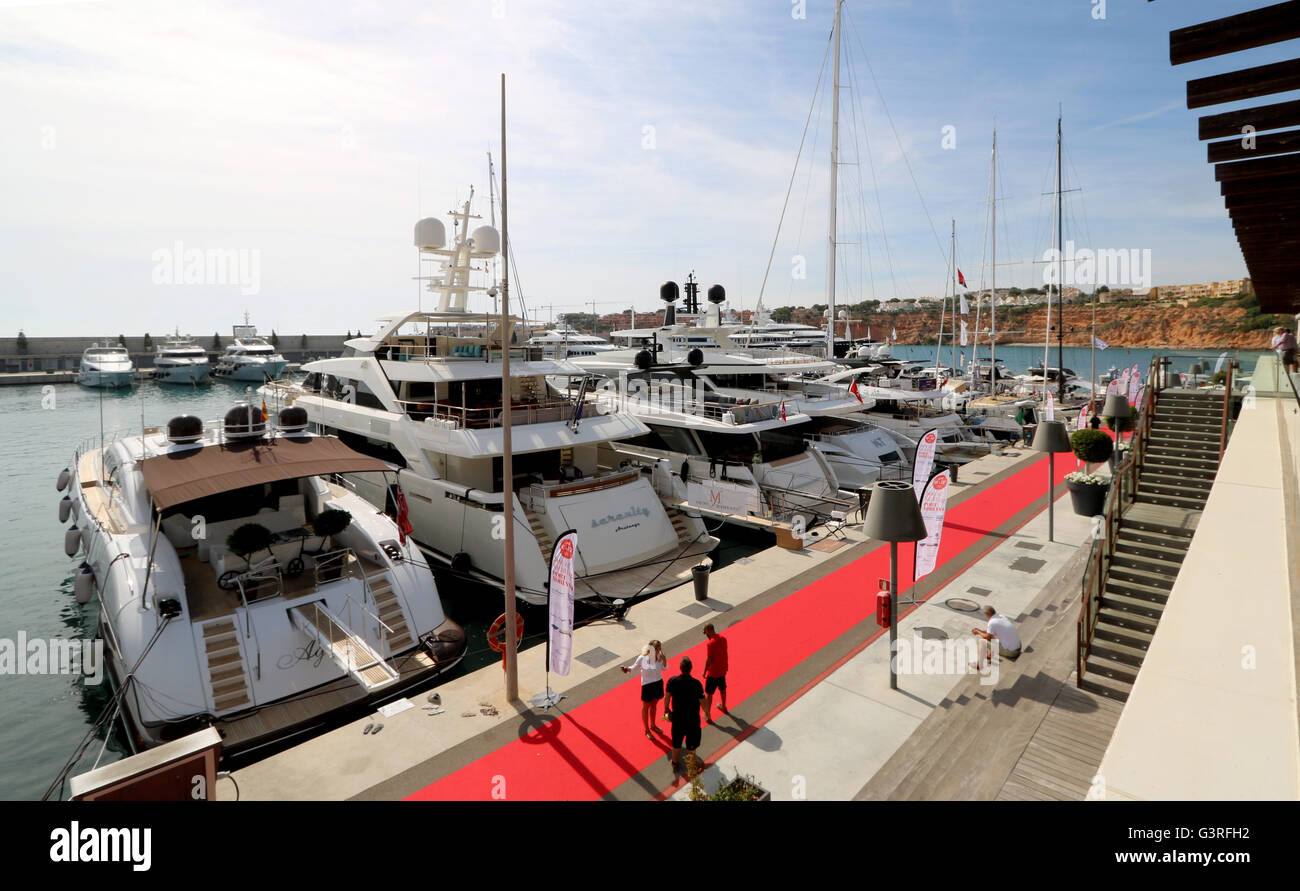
[{"xmin": 407, "ymin": 455, "xmax": 1074, "ymax": 801}]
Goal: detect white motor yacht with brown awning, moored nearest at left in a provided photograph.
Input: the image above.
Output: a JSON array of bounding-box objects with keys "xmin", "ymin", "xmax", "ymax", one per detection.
[{"xmin": 59, "ymin": 403, "xmax": 465, "ymax": 754}]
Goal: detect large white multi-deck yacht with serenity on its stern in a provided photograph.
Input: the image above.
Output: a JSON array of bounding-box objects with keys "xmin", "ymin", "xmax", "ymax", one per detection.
[{"xmin": 263, "ymin": 202, "xmax": 718, "ymax": 604}]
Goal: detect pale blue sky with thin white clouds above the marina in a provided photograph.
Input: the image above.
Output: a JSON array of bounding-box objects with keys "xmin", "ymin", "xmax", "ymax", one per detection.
[{"xmin": 0, "ymin": 0, "xmax": 1286, "ymax": 337}]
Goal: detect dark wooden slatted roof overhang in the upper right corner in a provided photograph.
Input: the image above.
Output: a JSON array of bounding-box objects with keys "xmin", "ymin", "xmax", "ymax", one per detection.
[{"xmin": 1169, "ymin": 0, "xmax": 1300, "ymax": 312}]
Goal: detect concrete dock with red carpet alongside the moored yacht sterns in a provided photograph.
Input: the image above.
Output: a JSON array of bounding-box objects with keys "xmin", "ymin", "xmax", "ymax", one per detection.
[{"xmin": 218, "ymin": 449, "xmax": 1110, "ymax": 800}]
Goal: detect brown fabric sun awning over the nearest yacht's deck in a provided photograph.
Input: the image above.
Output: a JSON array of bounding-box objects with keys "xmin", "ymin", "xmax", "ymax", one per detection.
[{"xmin": 140, "ymin": 437, "xmax": 393, "ymax": 510}]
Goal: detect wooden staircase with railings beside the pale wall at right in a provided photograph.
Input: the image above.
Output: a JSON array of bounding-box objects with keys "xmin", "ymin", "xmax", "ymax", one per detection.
[{"xmin": 1079, "ymin": 390, "xmax": 1223, "ymax": 701}]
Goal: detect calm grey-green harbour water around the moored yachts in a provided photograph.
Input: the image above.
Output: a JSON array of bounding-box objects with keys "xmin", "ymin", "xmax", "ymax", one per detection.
[{"xmin": 0, "ymin": 381, "xmax": 770, "ymax": 800}]
